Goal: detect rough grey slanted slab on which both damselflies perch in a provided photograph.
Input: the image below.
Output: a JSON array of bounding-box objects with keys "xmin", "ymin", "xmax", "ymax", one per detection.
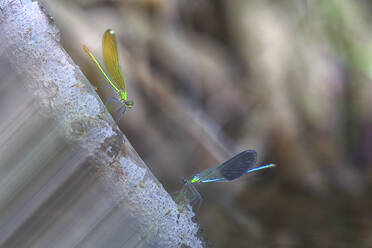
[{"xmin": 0, "ymin": 0, "xmax": 206, "ymax": 247}]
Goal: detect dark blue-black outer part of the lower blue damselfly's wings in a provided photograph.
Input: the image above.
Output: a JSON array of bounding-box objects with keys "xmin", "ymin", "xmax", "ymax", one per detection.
[{"xmin": 218, "ymin": 150, "xmax": 257, "ymax": 181}]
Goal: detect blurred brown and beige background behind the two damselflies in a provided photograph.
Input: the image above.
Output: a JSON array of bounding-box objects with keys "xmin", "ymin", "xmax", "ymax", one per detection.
[{"xmin": 15, "ymin": 0, "xmax": 372, "ymax": 247}]
